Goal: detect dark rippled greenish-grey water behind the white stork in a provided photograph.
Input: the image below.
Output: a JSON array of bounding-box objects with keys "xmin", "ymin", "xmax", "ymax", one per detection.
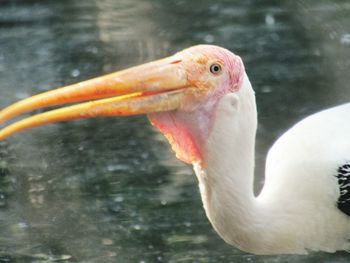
[{"xmin": 0, "ymin": 0, "xmax": 350, "ymax": 263}]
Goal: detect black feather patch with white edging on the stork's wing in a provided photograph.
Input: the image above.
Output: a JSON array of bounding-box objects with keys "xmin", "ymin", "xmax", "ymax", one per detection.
[{"xmin": 337, "ymin": 162, "xmax": 350, "ymax": 216}]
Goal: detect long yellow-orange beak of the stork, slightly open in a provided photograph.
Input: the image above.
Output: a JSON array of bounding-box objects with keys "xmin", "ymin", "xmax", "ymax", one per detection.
[{"xmin": 0, "ymin": 56, "xmax": 194, "ymax": 140}]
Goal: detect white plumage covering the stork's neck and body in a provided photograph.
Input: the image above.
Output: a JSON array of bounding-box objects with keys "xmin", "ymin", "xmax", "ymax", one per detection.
[{"xmin": 194, "ymin": 72, "xmax": 350, "ymax": 254}]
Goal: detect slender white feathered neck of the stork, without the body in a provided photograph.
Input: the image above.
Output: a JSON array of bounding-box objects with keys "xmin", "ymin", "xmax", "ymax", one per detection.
[{"xmin": 194, "ymin": 75, "xmax": 261, "ymax": 254}]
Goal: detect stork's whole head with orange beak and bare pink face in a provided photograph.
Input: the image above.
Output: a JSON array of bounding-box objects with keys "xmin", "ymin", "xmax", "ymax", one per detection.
[{"xmin": 0, "ymin": 45, "xmax": 244, "ymax": 166}]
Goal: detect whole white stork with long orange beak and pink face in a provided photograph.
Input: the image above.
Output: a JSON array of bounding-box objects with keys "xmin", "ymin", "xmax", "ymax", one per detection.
[{"xmin": 0, "ymin": 45, "xmax": 350, "ymax": 255}]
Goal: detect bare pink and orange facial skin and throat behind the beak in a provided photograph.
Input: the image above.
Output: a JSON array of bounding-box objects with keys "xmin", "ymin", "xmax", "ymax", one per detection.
[{"xmin": 148, "ymin": 45, "xmax": 244, "ymax": 166}]
